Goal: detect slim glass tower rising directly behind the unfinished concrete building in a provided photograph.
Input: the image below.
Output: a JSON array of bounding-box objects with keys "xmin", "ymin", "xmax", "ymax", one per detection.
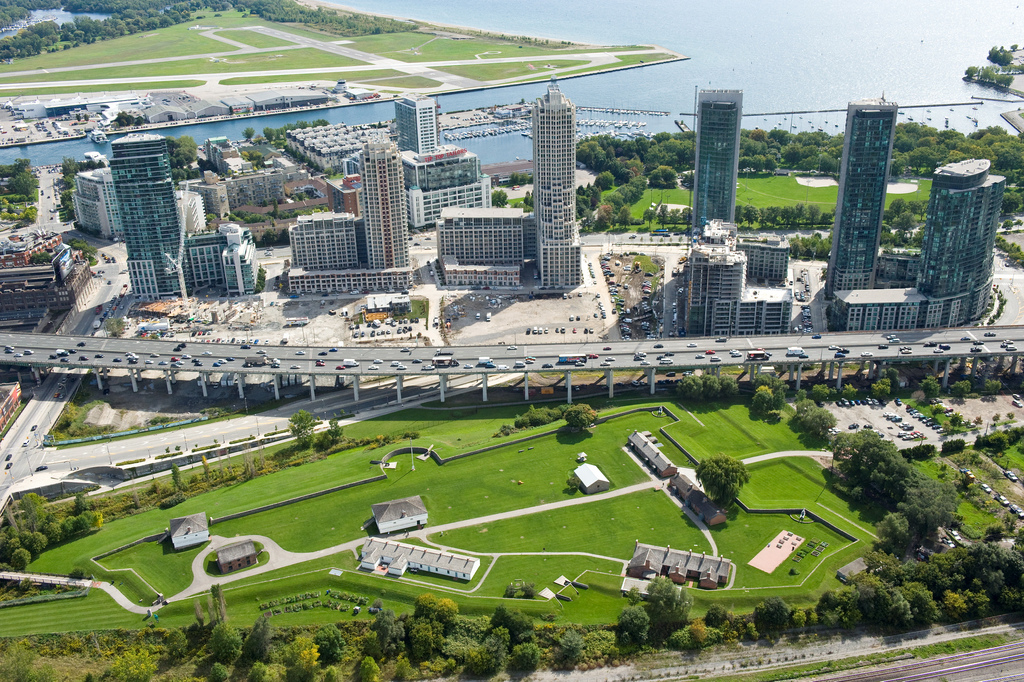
[{"xmin": 693, "ymin": 90, "xmax": 743, "ymax": 230}]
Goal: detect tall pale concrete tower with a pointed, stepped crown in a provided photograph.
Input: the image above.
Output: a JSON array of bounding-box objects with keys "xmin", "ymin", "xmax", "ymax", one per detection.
[{"xmin": 534, "ymin": 79, "xmax": 583, "ymax": 287}]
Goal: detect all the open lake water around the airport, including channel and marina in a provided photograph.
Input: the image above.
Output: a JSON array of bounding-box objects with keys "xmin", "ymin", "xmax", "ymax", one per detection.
[{"xmin": 0, "ymin": 0, "xmax": 1024, "ymax": 164}]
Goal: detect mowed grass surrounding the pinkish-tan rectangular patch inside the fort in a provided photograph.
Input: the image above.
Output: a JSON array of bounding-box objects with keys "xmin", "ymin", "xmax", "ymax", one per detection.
[{"xmin": 711, "ymin": 505, "xmax": 850, "ymax": 589}]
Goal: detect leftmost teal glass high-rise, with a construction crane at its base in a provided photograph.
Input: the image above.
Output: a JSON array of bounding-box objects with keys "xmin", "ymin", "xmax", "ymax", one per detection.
[{"xmin": 111, "ymin": 133, "xmax": 185, "ymax": 299}]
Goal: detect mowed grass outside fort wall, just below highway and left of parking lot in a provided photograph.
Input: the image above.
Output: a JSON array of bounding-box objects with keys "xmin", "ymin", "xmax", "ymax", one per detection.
[{"xmin": 666, "ymin": 402, "xmax": 824, "ymax": 460}]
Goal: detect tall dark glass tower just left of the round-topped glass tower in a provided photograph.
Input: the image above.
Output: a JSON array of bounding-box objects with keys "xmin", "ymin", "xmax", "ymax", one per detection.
[{"xmin": 825, "ymin": 99, "xmax": 898, "ymax": 297}]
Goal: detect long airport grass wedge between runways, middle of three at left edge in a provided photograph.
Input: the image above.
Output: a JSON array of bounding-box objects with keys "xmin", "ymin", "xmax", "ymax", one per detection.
[{"xmin": 3, "ymin": 47, "xmax": 364, "ymax": 88}]
